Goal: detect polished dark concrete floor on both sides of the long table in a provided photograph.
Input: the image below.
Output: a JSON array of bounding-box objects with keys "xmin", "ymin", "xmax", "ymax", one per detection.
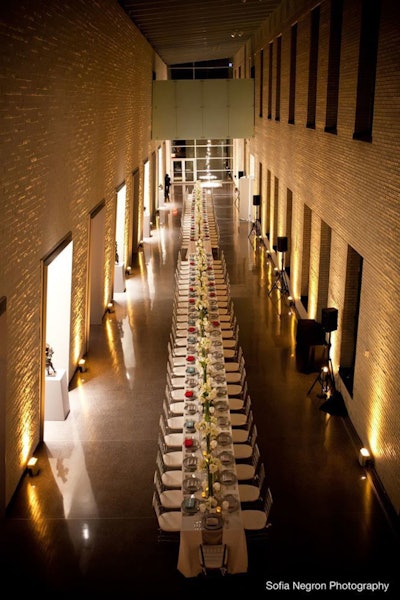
[{"xmin": 1, "ymin": 186, "xmax": 399, "ymax": 600}]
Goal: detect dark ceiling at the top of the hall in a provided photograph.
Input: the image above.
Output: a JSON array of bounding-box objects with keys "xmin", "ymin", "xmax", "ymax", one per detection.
[{"xmin": 118, "ymin": 0, "xmax": 282, "ymax": 65}]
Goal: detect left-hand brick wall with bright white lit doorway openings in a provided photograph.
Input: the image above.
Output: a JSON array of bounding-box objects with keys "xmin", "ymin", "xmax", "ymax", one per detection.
[{"xmin": 0, "ymin": 0, "xmax": 160, "ymax": 502}]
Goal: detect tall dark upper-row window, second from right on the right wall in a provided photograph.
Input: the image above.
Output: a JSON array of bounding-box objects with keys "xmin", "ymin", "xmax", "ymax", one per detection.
[{"xmin": 325, "ymin": 0, "xmax": 343, "ymax": 133}]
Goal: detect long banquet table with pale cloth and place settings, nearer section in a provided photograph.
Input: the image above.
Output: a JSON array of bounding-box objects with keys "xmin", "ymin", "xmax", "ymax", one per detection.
[{"xmin": 178, "ymin": 252, "xmax": 248, "ymax": 577}]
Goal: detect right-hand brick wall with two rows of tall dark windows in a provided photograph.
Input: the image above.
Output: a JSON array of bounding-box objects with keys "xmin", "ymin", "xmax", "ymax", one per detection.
[{"xmin": 247, "ymin": 0, "xmax": 400, "ymax": 511}]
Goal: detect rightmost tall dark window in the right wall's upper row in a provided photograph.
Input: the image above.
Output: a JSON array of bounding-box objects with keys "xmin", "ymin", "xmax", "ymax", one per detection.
[{"xmin": 353, "ymin": 0, "xmax": 380, "ymax": 142}]
